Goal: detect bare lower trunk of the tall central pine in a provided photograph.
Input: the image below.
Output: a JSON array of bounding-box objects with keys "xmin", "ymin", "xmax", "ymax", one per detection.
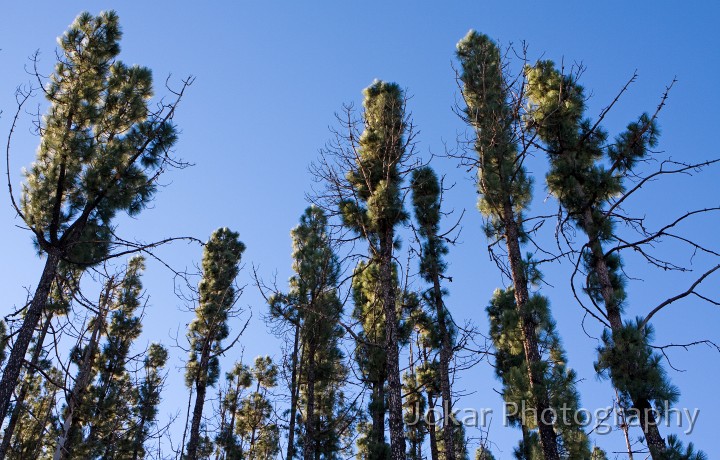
[{"xmin": 380, "ymin": 234, "xmax": 405, "ymax": 460}]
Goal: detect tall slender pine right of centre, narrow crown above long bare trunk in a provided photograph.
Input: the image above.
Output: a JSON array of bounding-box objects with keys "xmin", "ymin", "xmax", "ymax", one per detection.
[{"xmin": 457, "ymin": 31, "xmax": 560, "ymax": 460}]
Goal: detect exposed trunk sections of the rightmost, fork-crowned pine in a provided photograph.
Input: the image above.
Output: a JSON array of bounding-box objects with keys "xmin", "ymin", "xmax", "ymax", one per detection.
[{"xmin": 582, "ymin": 208, "xmax": 667, "ymax": 460}]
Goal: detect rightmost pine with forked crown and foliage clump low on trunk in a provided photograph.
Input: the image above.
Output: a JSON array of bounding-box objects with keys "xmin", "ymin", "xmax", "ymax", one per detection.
[{"xmin": 526, "ymin": 61, "xmax": 704, "ymax": 460}]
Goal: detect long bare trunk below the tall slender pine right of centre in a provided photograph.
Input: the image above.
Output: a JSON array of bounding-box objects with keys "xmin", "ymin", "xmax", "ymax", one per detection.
[{"xmin": 503, "ymin": 205, "xmax": 560, "ymax": 460}]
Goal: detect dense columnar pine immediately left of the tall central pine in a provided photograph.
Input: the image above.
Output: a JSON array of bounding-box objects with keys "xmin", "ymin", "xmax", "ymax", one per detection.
[{"xmin": 270, "ymin": 207, "xmax": 347, "ymax": 460}]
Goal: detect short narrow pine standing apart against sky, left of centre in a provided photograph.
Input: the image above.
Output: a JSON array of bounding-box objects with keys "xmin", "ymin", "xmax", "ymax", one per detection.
[{"xmin": 185, "ymin": 228, "xmax": 245, "ymax": 460}]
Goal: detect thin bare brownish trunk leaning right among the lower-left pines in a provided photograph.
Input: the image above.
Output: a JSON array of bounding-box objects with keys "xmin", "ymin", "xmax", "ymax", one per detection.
[{"xmin": 53, "ymin": 292, "xmax": 111, "ymax": 460}]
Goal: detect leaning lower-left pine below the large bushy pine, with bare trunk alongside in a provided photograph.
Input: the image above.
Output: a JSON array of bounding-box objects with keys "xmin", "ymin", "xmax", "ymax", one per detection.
[{"xmin": 54, "ymin": 257, "xmax": 154, "ymax": 459}]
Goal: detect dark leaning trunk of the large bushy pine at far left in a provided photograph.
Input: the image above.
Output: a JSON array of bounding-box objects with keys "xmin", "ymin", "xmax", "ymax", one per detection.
[{"xmin": 0, "ymin": 251, "xmax": 60, "ymax": 420}]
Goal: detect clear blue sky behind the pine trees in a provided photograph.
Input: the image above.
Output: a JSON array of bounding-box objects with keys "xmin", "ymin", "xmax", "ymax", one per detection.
[{"xmin": 0, "ymin": 0, "xmax": 720, "ymax": 458}]
